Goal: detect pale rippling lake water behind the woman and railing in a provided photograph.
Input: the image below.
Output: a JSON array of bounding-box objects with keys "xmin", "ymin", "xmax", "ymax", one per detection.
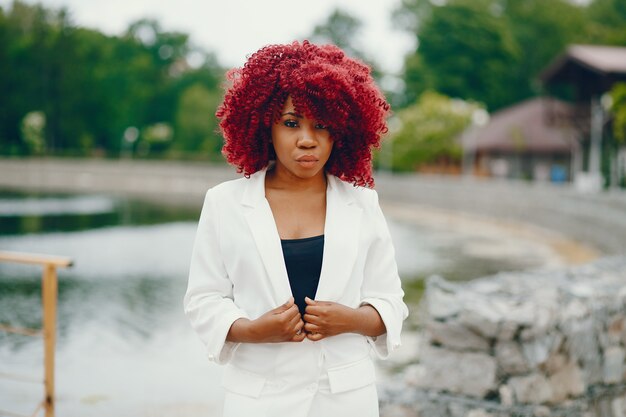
[{"xmin": 0, "ymin": 192, "xmax": 554, "ymax": 417}]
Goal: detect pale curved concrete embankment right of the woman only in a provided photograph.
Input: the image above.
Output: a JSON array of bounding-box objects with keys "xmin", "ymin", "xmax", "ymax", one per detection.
[{"xmin": 376, "ymin": 171, "xmax": 626, "ymax": 255}]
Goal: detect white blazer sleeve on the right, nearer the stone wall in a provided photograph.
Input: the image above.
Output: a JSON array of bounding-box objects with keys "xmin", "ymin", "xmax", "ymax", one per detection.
[{"xmin": 361, "ymin": 191, "xmax": 409, "ymax": 359}]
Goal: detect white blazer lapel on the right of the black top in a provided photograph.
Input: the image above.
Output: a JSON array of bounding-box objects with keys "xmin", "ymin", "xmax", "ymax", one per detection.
[{"xmin": 315, "ymin": 175, "xmax": 362, "ymax": 301}]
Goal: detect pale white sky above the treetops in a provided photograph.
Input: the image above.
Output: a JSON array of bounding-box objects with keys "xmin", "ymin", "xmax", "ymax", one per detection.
[{"xmin": 0, "ymin": 0, "xmax": 414, "ymax": 74}]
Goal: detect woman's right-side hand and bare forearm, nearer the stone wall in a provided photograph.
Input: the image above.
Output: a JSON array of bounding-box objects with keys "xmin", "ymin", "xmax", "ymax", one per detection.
[{"xmin": 304, "ymin": 297, "xmax": 386, "ymax": 341}]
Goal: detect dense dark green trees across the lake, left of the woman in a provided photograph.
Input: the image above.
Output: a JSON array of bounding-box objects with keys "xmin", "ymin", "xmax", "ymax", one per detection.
[{"xmin": 0, "ymin": 1, "xmax": 223, "ymax": 155}]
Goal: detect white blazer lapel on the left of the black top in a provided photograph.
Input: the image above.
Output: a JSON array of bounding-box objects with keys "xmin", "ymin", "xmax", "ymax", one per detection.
[{"xmin": 241, "ymin": 170, "xmax": 291, "ymax": 305}]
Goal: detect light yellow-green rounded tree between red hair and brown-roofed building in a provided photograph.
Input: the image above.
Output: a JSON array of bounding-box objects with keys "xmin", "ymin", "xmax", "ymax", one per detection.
[{"xmin": 386, "ymin": 92, "xmax": 480, "ymax": 171}]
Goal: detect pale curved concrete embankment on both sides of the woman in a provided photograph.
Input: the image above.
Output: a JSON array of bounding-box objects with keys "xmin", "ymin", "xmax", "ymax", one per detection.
[{"xmin": 0, "ymin": 159, "xmax": 626, "ymax": 255}]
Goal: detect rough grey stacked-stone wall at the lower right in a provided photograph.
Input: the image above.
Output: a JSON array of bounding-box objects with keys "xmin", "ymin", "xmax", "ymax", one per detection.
[{"xmin": 381, "ymin": 257, "xmax": 626, "ymax": 417}]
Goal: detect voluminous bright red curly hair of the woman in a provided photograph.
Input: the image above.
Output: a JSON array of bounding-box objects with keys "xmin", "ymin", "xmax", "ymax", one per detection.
[{"xmin": 216, "ymin": 40, "xmax": 390, "ymax": 187}]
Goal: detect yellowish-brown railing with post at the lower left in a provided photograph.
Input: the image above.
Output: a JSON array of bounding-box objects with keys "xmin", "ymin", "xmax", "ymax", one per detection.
[{"xmin": 0, "ymin": 251, "xmax": 72, "ymax": 417}]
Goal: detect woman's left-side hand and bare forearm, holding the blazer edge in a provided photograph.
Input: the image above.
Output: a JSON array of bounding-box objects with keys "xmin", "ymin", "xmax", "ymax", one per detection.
[{"xmin": 226, "ymin": 297, "xmax": 306, "ymax": 343}]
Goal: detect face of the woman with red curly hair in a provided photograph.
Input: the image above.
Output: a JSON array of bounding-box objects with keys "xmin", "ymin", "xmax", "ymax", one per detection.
[{"xmin": 272, "ymin": 97, "xmax": 333, "ymax": 179}]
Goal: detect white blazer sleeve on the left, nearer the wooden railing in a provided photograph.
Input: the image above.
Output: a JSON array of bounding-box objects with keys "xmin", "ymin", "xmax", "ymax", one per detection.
[{"xmin": 183, "ymin": 189, "xmax": 247, "ymax": 364}]
